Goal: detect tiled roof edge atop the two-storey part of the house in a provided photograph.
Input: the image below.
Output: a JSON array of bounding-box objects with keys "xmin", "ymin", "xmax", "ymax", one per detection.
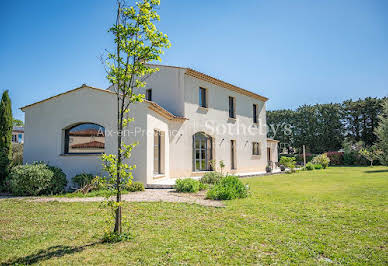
[{"xmin": 148, "ymin": 64, "xmax": 268, "ymax": 102}]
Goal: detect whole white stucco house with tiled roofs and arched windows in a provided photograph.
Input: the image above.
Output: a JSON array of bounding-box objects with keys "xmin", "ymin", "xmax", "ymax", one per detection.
[{"xmin": 21, "ymin": 65, "xmax": 277, "ymax": 184}]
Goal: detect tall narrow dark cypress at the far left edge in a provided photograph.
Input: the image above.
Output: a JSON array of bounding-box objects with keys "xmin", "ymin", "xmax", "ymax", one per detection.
[{"xmin": 0, "ymin": 90, "xmax": 12, "ymax": 185}]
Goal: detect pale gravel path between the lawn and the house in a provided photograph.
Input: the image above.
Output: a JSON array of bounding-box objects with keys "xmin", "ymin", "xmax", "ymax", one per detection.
[{"xmin": 0, "ymin": 189, "xmax": 225, "ymax": 207}]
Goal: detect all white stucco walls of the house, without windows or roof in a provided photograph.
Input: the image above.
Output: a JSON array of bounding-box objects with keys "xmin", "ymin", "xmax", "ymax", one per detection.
[{"xmin": 24, "ymin": 67, "xmax": 277, "ymax": 184}]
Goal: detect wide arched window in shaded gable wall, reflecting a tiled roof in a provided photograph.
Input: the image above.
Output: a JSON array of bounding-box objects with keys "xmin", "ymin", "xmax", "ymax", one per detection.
[{"xmin": 65, "ymin": 123, "xmax": 105, "ymax": 154}]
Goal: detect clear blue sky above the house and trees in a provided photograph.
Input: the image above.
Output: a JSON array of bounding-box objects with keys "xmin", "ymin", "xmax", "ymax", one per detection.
[{"xmin": 0, "ymin": 0, "xmax": 388, "ymax": 119}]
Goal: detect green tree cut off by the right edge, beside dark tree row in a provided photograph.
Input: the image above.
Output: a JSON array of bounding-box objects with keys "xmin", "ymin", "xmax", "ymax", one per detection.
[{"xmin": 375, "ymin": 98, "xmax": 388, "ymax": 165}]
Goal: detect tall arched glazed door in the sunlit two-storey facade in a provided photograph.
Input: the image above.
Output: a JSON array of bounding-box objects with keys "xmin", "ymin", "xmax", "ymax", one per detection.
[{"xmin": 193, "ymin": 132, "xmax": 213, "ymax": 171}]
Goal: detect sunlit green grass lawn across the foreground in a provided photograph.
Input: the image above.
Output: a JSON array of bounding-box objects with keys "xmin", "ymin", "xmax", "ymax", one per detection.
[{"xmin": 0, "ymin": 167, "xmax": 388, "ymax": 265}]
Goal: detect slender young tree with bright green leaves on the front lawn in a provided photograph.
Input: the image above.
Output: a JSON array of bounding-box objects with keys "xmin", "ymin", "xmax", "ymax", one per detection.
[{"xmin": 102, "ymin": 0, "xmax": 170, "ymax": 236}]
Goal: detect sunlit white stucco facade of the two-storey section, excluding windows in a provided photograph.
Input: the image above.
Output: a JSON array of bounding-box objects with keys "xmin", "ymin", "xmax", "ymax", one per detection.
[{"xmin": 170, "ymin": 75, "xmax": 267, "ymax": 177}]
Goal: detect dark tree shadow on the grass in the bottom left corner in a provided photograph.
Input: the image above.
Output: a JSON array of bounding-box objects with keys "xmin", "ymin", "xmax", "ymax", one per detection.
[{"xmin": 0, "ymin": 241, "xmax": 101, "ymax": 265}]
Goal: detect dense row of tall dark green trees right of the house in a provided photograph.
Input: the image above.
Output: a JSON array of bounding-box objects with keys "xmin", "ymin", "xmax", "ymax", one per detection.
[{"xmin": 267, "ymin": 97, "xmax": 385, "ymax": 156}]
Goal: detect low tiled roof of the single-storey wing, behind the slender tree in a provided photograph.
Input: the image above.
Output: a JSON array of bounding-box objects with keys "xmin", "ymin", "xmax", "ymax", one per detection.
[{"xmin": 20, "ymin": 84, "xmax": 187, "ymax": 121}]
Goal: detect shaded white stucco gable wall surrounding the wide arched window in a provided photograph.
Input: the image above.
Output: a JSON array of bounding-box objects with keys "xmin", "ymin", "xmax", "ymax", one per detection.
[{"xmin": 24, "ymin": 87, "xmax": 148, "ymax": 185}]
